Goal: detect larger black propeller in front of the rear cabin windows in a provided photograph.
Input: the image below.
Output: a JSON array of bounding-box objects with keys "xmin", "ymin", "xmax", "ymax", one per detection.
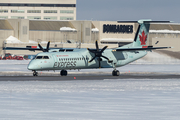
[{"xmin": 87, "ymin": 40, "xmax": 109, "ymax": 68}]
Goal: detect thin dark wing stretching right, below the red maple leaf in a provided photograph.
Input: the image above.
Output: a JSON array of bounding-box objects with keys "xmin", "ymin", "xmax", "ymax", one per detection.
[{"xmin": 114, "ymin": 46, "xmax": 172, "ymax": 51}]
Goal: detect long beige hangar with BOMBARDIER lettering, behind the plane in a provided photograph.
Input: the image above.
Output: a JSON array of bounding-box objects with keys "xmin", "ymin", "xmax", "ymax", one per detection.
[{"xmin": 0, "ymin": 19, "xmax": 180, "ymax": 54}]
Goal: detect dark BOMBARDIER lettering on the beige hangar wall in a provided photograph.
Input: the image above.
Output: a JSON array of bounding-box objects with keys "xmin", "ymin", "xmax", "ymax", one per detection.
[{"xmin": 103, "ymin": 24, "xmax": 133, "ymax": 34}]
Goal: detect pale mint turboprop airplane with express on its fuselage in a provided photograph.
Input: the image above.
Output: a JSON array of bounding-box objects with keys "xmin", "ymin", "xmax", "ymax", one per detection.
[{"xmin": 4, "ymin": 20, "xmax": 170, "ymax": 76}]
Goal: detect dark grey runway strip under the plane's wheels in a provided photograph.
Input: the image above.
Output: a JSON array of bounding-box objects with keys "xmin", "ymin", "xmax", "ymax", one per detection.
[{"xmin": 0, "ymin": 73, "xmax": 180, "ymax": 81}]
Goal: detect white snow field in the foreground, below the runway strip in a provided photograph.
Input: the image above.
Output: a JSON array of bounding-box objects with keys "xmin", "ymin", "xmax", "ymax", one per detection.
[{"xmin": 0, "ymin": 79, "xmax": 180, "ymax": 120}]
